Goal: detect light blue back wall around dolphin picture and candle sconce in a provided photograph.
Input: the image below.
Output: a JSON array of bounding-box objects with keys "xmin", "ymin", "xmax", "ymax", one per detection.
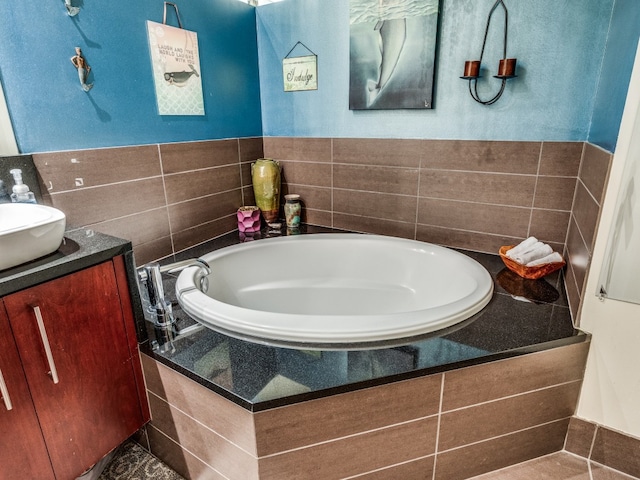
[{"xmin": 257, "ymin": 0, "xmax": 640, "ymax": 150}]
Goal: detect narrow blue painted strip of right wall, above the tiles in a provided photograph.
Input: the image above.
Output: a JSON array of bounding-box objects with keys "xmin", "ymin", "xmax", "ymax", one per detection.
[{"xmin": 589, "ymin": 0, "xmax": 640, "ymax": 152}]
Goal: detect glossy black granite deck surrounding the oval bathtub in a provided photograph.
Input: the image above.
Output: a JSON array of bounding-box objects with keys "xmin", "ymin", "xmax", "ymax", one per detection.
[{"xmin": 141, "ymin": 226, "xmax": 587, "ymax": 411}]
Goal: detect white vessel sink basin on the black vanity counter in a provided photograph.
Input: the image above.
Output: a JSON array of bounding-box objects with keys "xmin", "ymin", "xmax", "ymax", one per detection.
[{"xmin": 0, "ymin": 203, "xmax": 66, "ymax": 270}]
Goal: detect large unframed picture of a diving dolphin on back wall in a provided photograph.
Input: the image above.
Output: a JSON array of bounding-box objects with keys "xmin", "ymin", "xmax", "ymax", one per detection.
[{"xmin": 349, "ymin": 0, "xmax": 439, "ymax": 110}]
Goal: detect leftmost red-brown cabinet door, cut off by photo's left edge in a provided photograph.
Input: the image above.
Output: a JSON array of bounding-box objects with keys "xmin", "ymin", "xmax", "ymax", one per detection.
[{"xmin": 0, "ymin": 300, "xmax": 54, "ymax": 480}]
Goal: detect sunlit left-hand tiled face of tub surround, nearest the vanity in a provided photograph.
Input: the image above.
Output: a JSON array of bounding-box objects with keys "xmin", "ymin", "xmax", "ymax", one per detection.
[{"xmin": 141, "ymin": 354, "xmax": 258, "ymax": 480}]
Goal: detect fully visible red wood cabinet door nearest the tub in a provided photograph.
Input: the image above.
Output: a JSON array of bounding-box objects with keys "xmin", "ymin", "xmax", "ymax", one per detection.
[{"xmin": 4, "ymin": 262, "xmax": 143, "ymax": 479}]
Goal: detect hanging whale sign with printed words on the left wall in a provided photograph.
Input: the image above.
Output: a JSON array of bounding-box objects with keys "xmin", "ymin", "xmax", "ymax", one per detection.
[{"xmin": 147, "ymin": 21, "xmax": 204, "ymax": 115}]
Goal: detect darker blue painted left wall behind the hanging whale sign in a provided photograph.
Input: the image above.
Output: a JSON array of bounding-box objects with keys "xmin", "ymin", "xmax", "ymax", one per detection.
[{"xmin": 0, "ymin": 0, "xmax": 262, "ymax": 153}]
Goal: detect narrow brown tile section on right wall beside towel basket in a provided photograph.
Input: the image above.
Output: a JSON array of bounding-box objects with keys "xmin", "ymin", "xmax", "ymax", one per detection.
[{"xmin": 566, "ymin": 143, "xmax": 613, "ymax": 321}]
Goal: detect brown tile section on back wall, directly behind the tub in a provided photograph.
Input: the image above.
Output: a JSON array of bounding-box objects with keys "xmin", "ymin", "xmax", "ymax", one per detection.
[{"xmin": 264, "ymin": 137, "xmax": 583, "ymax": 253}]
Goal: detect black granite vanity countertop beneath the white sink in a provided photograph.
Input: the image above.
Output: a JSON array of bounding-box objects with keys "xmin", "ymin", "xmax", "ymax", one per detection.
[{"xmin": 0, "ymin": 228, "xmax": 132, "ymax": 297}]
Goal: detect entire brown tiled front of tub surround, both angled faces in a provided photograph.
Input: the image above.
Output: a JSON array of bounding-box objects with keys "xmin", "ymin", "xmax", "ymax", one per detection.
[{"xmin": 143, "ymin": 342, "xmax": 589, "ymax": 480}]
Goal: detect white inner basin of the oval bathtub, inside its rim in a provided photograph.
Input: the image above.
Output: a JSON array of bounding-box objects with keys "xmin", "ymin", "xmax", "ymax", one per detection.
[{"xmin": 203, "ymin": 235, "xmax": 479, "ymax": 315}]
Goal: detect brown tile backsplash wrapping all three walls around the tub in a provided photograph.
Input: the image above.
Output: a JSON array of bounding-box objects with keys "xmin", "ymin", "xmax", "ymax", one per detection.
[{"xmin": 28, "ymin": 137, "xmax": 612, "ymax": 318}]
